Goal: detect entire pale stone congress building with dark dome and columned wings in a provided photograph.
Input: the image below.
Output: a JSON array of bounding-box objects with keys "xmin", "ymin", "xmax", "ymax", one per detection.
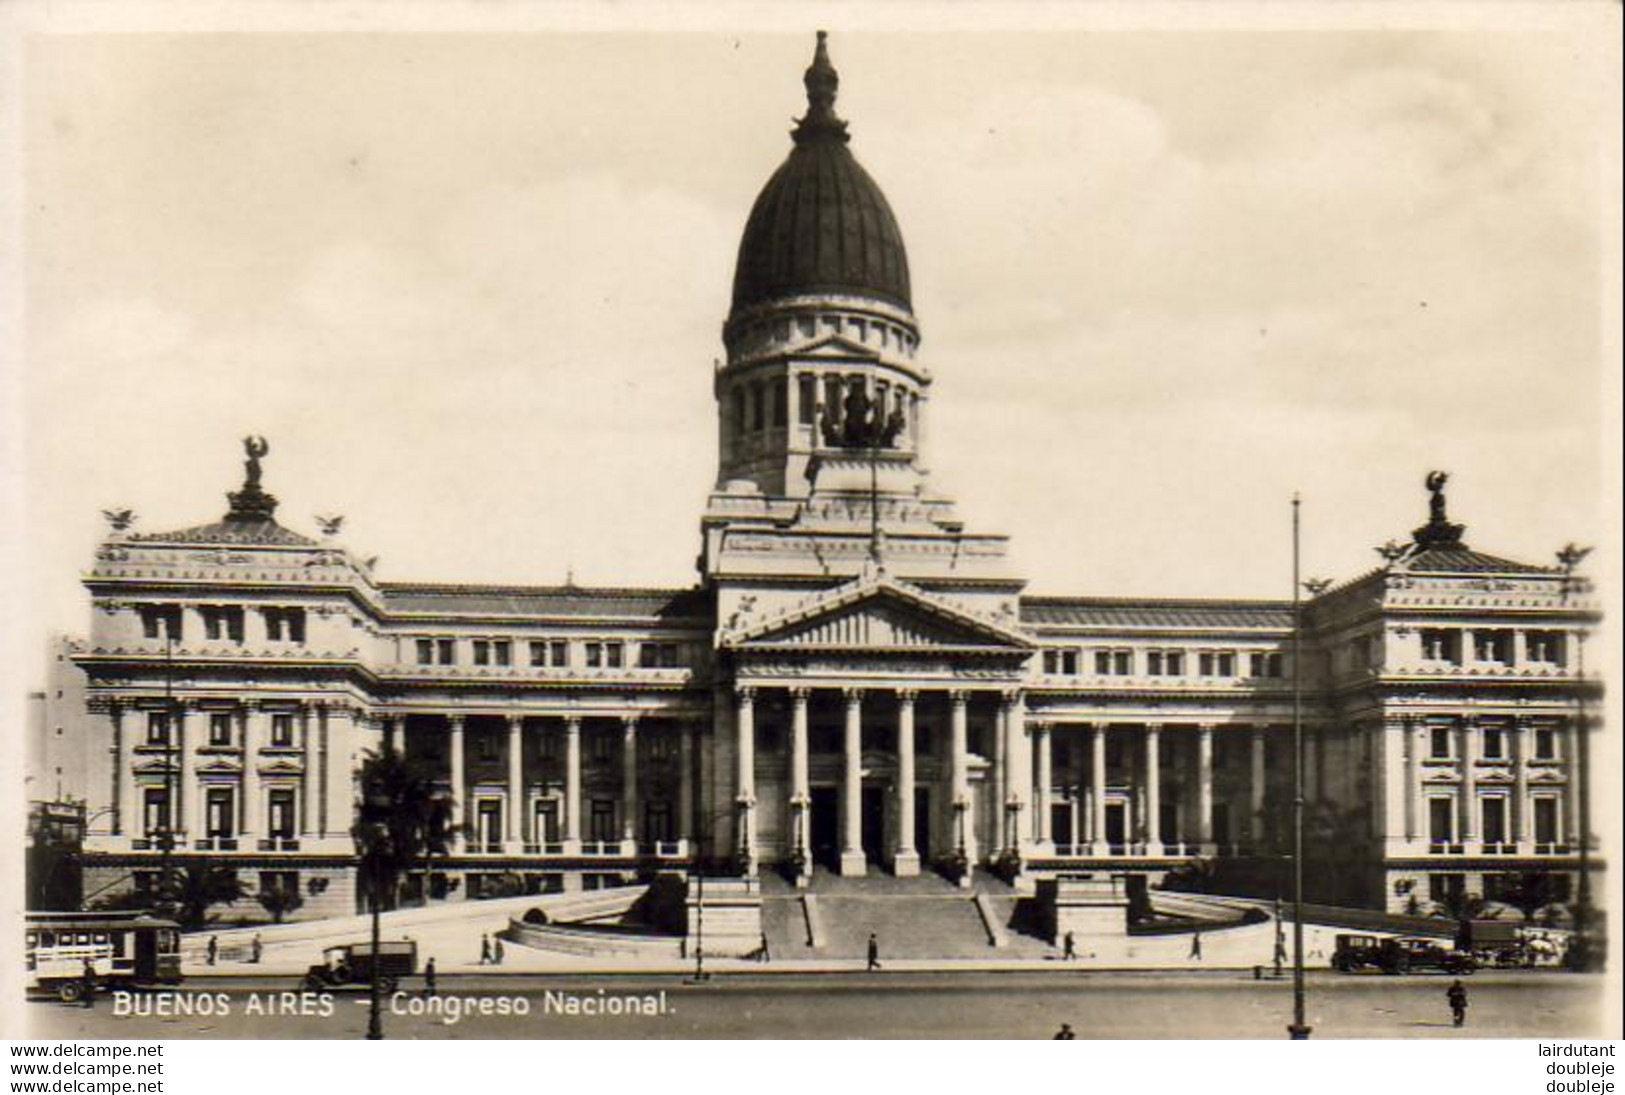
[{"xmin": 37, "ymin": 36, "xmax": 1597, "ymax": 916}]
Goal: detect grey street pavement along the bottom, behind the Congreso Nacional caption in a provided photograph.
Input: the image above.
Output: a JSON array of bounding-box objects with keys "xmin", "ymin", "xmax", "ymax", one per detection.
[{"xmin": 28, "ymin": 963, "xmax": 1607, "ymax": 1040}]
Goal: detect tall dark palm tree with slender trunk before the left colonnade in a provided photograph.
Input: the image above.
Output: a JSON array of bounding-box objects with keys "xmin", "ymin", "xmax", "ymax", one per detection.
[{"xmin": 351, "ymin": 747, "xmax": 452, "ymax": 1040}]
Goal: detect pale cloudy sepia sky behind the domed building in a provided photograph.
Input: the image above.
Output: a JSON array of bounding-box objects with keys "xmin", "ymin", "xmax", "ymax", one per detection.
[{"xmin": 10, "ymin": 10, "xmax": 1619, "ymax": 672}]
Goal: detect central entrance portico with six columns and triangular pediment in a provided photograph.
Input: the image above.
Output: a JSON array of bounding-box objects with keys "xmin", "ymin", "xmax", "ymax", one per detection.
[{"xmin": 720, "ymin": 567, "xmax": 1032, "ymax": 881}]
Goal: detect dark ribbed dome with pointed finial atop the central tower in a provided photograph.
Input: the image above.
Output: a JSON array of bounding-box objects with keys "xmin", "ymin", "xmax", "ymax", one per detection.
[{"xmin": 733, "ymin": 32, "xmax": 912, "ymax": 314}]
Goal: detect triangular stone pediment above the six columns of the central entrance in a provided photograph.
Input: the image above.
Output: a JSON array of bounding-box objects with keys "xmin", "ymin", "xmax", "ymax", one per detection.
[{"xmin": 722, "ymin": 575, "xmax": 1034, "ymax": 653}]
